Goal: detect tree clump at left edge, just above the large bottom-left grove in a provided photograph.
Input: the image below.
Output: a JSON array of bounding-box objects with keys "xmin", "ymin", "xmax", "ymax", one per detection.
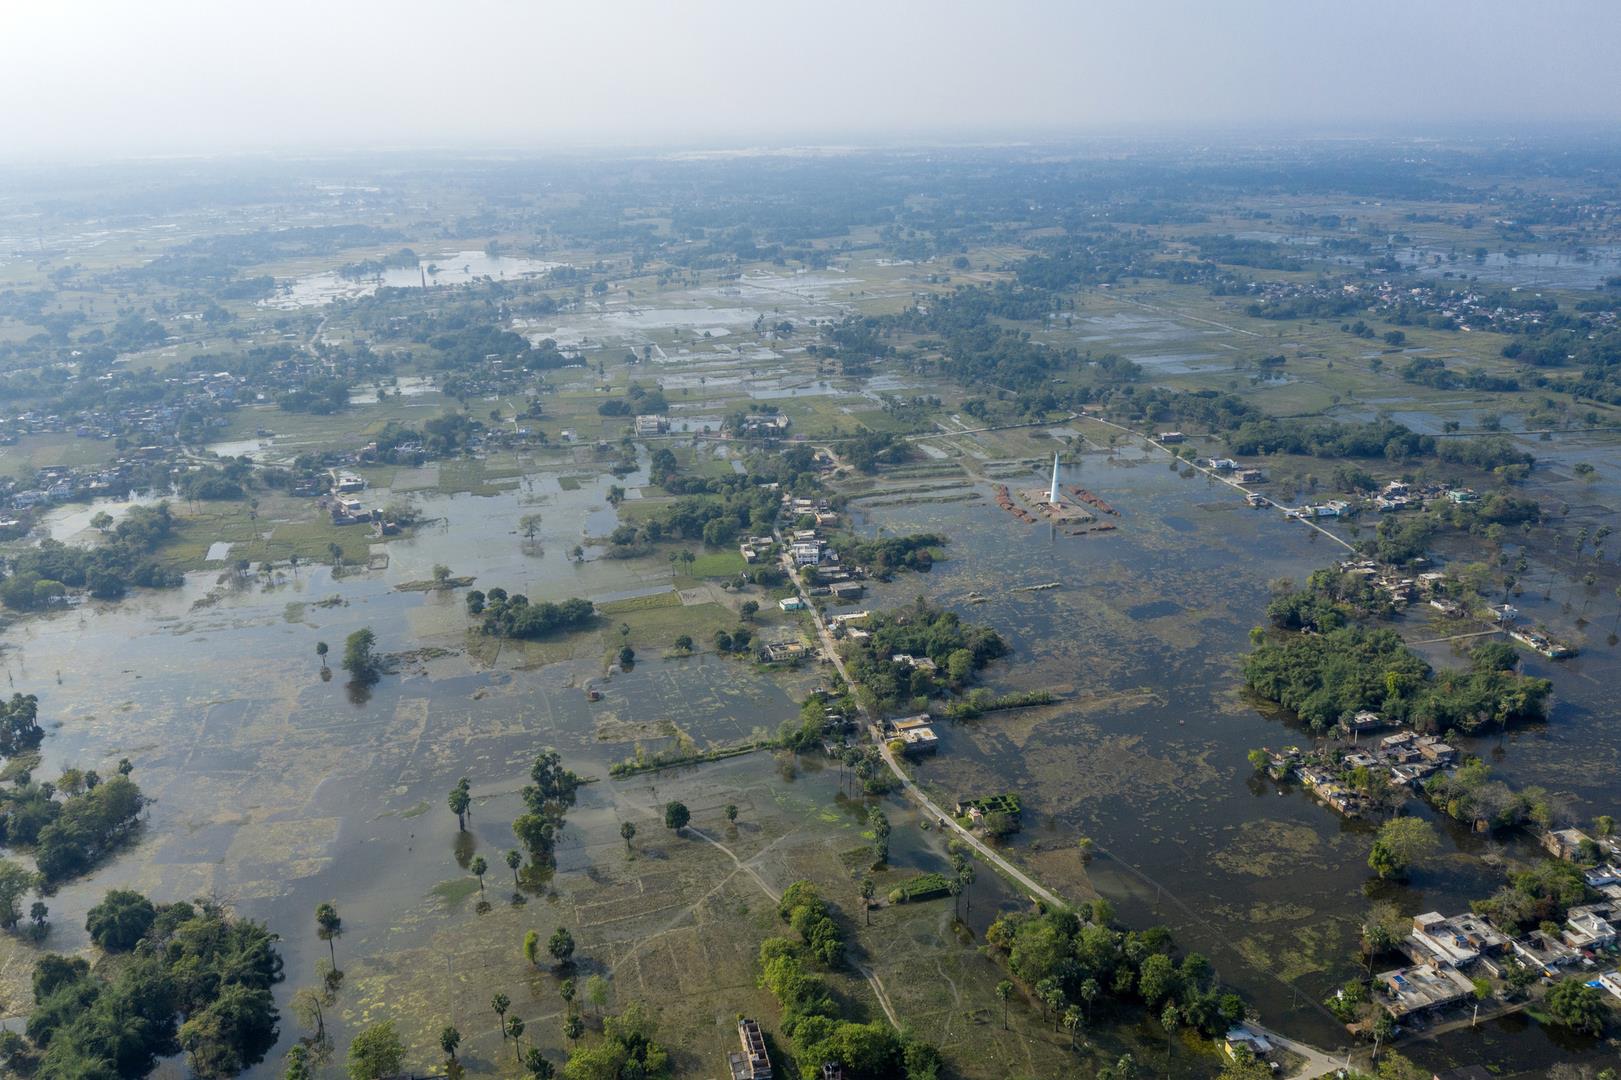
[{"xmin": 0, "ymin": 761, "xmax": 146, "ymax": 885}]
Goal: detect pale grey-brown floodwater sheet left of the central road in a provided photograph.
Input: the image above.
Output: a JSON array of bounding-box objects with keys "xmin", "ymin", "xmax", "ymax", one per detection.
[{"xmin": 0, "ymin": 457, "xmax": 814, "ymax": 1077}]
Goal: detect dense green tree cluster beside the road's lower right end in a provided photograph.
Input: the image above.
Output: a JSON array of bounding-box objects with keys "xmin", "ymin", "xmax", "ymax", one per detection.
[{"xmin": 986, "ymin": 900, "xmax": 1243, "ymax": 1038}]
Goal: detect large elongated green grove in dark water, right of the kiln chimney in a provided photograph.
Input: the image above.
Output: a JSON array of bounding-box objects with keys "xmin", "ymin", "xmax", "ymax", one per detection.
[{"xmin": 1243, "ymin": 612, "xmax": 1553, "ymax": 733}]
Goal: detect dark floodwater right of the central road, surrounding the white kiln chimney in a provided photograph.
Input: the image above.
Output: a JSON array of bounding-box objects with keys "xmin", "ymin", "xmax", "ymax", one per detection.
[{"xmin": 867, "ymin": 441, "xmax": 1621, "ymax": 1061}]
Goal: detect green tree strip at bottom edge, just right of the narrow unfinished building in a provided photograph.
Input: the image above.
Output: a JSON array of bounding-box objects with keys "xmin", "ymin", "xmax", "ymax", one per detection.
[{"xmin": 760, "ymin": 881, "xmax": 942, "ymax": 1080}]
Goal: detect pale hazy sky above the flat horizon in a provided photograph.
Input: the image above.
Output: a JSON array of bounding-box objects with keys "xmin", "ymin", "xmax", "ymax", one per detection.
[{"xmin": 0, "ymin": 0, "xmax": 1621, "ymax": 157}]
